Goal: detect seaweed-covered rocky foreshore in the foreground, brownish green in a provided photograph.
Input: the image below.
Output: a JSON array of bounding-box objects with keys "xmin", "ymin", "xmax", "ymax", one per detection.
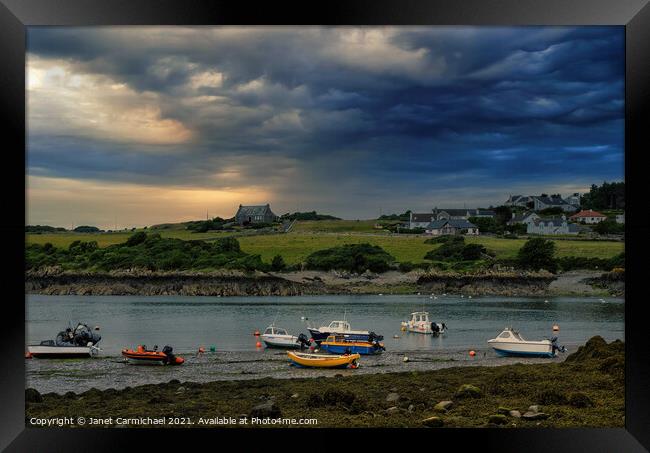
[{"xmin": 26, "ymin": 337, "xmax": 625, "ymax": 428}]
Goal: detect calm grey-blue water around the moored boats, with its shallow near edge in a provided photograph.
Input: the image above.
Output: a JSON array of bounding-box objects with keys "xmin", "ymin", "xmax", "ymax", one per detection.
[{"xmin": 26, "ymin": 295, "xmax": 624, "ymax": 393}]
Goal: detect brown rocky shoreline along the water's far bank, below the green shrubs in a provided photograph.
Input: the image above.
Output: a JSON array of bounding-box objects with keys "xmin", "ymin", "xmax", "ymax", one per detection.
[{"xmin": 25, "ymin": 269, "xmax": 624, "ymax": 297}]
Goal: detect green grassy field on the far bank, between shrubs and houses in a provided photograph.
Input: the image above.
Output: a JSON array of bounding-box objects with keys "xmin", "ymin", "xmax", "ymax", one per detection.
[{"xmin": 26, "ymin": 220, "xmax": 624, "ymax": 264}]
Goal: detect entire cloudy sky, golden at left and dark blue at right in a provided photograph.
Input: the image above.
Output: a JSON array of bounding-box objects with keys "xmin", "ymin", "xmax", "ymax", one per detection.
[{"xmin": 26, "ymin": 27, "xmax": 624, "ymax": 228}]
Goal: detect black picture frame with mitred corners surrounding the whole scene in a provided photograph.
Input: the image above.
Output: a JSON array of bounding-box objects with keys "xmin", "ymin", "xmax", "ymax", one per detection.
[{"xmin": 0, "ymin": 0, "xmax": 650, "ymax": 452}]
